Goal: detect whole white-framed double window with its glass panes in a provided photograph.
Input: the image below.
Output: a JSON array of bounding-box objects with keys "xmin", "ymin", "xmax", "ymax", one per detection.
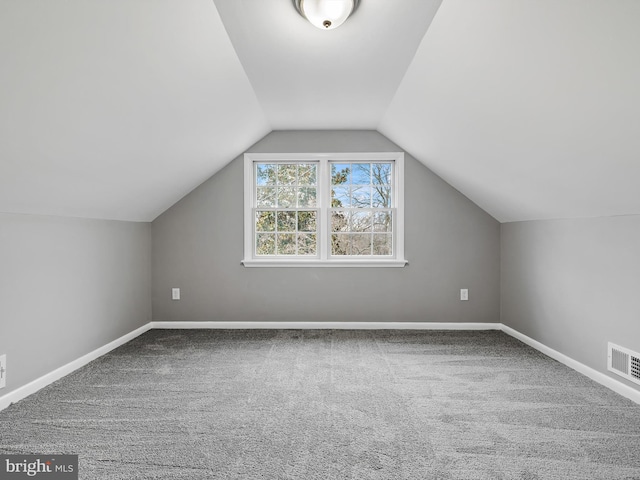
[{"xmin": 242, "ymin": 153, "xmax": 407, "ymax": 267}]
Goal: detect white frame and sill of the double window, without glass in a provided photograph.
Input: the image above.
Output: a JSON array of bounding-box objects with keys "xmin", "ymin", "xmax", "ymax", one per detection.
[{"xmin": 241, "ymin": 152, "xmax": 408, "ymax": 267}]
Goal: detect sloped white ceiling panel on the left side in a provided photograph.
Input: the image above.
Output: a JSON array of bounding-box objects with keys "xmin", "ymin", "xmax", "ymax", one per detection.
[{"xmin": 0, "ymin": 0, "xmax": 270, "ymax": 221}]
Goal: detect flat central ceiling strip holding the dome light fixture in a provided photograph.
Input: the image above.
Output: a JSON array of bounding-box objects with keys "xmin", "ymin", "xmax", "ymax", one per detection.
[{"xmin": 214, "ymin": 0, "xmax": 441, "ymax": 130}]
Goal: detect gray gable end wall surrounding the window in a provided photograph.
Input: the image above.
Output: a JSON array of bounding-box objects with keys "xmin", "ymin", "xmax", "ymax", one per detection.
[{"xmin": 153, "ymin": 131, "xmax": 500, "ymax": 322}]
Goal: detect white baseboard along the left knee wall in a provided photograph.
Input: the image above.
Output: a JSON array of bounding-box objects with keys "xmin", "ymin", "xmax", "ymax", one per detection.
[{"xmin": 0, "ymin": 323, "xmax": 152, "ymax": 411}]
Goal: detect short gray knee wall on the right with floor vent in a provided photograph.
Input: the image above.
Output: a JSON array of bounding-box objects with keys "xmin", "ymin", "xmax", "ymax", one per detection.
[{"xmin": 501, "ymin": 216, "xmax": 640, "ymax": 388}]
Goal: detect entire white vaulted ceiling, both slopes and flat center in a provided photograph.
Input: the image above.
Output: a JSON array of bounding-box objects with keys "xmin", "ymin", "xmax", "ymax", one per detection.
[{"xmin": 0, "ymin": 0, "xmax": 640, "ymax": 222}]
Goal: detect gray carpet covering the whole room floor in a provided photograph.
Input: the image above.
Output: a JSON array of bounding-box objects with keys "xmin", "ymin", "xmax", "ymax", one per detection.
[{"xmin": 0, "ymin": 330, "xmax": 640, "ymax": 480}]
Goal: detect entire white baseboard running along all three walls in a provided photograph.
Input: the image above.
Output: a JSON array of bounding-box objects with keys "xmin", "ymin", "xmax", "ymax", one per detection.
[{"xmin": 0, "ymin": 322, "xmax": 640, "ymax": 410}]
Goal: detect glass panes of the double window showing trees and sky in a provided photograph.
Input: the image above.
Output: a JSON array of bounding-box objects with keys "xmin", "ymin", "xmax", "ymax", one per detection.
[{"xmin": 254, "ymin": 162, "xmax": 393, "ymax": 257}]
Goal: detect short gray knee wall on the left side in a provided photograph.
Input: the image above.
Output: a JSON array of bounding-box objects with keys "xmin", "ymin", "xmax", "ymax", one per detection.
[{"xmin": 0, "ymin": 214, "xmax": 151, "ymax": 396}]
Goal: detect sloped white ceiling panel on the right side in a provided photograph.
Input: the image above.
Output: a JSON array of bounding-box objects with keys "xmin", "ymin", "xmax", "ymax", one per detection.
[{"xmin": 379, "ymin": 0, "xmax": 640, "ymax": 222}]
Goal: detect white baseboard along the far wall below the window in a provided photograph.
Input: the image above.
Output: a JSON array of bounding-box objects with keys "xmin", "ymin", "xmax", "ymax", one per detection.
[{"xmin": 151, "ymin": 322, "xmax": 502, "ymax": 330}]
